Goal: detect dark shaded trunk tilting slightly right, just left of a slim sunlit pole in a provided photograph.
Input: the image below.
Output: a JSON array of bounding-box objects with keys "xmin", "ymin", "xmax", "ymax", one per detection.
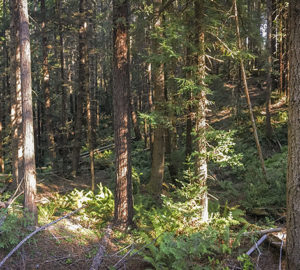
[{"xmin": 72, "ymin": 0, "xmax": 88, "ymax": 177}]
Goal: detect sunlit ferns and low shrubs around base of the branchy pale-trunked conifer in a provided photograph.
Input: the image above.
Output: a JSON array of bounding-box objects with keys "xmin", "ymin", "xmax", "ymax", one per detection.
[{"xmin": 135, "ymin": 178, "xmax": 245, "ymax": 269}]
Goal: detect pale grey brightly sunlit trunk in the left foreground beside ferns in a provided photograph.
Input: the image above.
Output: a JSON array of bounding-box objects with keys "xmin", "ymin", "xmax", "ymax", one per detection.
[{"xmin": 19, "ymin": 0, "xmax": 37, "ymax": 223}]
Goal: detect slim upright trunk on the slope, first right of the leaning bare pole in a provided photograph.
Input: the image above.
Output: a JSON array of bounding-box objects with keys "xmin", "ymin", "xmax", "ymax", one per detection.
[{"xmin": 266, "ymin": 0, "xmax": 273, "ymax": 139}]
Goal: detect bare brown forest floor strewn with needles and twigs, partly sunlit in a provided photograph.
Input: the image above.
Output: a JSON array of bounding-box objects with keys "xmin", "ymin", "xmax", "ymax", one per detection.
[{"xmin": 0, "ymin": 77, "xmax": 286, "ymax": 270}]
